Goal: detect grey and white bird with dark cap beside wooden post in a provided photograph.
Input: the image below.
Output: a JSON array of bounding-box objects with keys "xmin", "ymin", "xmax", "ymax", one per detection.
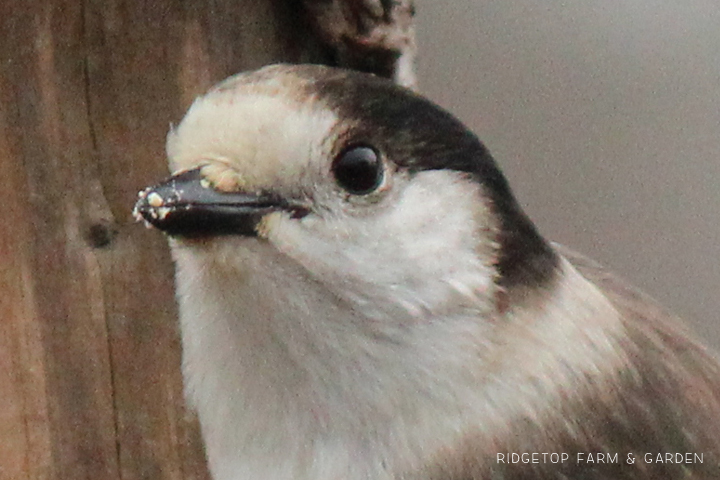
[{"xmin": 134, "ymin": 64, "xmax": 720, "ymax": 480}]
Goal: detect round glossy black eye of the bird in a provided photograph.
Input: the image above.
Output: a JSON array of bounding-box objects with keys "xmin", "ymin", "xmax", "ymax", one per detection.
[{"xmin": 332, "ymin": 146, "xmax": 383, "ymax": 195}]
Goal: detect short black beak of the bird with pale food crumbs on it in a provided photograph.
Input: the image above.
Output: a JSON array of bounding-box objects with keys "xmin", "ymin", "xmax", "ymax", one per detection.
[{"xmin": 133, "ymin": 168, "xmax": 307, "ymax": 237}]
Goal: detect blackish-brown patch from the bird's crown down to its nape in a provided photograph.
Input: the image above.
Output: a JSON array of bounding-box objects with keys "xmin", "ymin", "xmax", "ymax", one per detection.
[{"xmin": 308, "ymin": 69, "xmax": 559, "ymax": 289}]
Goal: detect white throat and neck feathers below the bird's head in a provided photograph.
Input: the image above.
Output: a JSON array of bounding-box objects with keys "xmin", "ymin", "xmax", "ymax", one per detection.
[{"xmin": 174, "ymin": 242, "xmax": 628, "ymax": 480}]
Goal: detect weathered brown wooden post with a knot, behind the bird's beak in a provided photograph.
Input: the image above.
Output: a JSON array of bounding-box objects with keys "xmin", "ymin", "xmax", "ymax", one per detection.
[{"xmin": 0, "ymin": 0, "xmax": 414, "ymax": 480}]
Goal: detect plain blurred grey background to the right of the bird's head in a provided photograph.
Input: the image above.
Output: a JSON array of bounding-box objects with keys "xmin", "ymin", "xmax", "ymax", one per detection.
[{"xmin": 417, "ymin": 0, "xmax": 720, "ymax": 351}]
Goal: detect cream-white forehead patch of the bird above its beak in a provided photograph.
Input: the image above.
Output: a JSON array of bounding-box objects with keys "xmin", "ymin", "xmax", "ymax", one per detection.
[{"xmin": 167, "ymin": 80, "xmax": 338, "ymax": 188}]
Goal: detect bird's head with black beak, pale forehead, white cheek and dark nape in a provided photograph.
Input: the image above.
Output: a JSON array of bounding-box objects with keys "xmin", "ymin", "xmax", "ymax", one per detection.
[{"xmin": 136, "ymin": 65, "xmax": 555, "ymax": 318}]
